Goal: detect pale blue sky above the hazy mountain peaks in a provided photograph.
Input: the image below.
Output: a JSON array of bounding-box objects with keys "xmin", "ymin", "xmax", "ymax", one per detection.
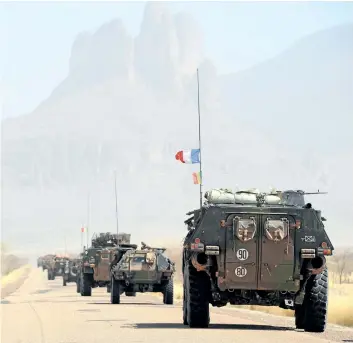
[{"xmin": 0, "ymin": 1, "xmax": 353, "ymax": 117}]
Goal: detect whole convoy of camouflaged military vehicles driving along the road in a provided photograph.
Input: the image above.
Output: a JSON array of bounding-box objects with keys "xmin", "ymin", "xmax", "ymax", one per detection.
[{"xmin": 38, "ymin": 189, "xmax": 334, "ymax": 332}]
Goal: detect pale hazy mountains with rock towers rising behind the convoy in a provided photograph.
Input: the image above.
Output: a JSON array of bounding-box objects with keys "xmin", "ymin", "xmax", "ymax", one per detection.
[{"xmin": 1, "ymin": 3, "xmax": 353, "ymax": 264}]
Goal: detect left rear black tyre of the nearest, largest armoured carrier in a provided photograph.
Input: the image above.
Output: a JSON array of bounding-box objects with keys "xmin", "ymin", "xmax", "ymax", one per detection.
[{"xmin": 184, "ymin": 262, "xmax": 210, "ymax": 328}]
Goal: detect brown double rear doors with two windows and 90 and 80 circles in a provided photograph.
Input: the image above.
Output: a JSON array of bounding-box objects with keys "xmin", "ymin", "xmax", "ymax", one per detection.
[{"xmin": 225, "ymin": 213, "xmax": 296, "ymax": 290}]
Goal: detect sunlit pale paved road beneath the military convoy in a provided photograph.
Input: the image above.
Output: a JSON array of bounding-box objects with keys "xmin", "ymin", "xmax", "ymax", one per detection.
[{"xmin": 1, "ymin": 269, "xmax": 353, "ymax": 343}]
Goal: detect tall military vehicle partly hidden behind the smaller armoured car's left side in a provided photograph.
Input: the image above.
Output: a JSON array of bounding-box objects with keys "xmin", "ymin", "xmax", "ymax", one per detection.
[{"xmin": 79, "ymin": 232, "xmax": 131, "ymax": 296}]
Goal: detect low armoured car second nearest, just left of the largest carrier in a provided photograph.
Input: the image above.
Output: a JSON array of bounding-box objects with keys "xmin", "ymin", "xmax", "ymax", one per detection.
[{"xmin": 110, "ymin": 242, "xmax": 175, "ymax": 304}]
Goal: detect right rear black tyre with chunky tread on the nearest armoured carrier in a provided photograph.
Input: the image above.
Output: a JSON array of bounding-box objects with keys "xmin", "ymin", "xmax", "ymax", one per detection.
[{"xmin": 303, "ymin": 268, "xmax": 328, "ymax": 332}]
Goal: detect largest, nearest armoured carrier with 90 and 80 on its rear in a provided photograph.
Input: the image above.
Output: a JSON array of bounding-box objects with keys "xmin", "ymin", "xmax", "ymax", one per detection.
[{"xmin": 183, "ymin": 189, "xmax": 334, "ymax": 332}]
